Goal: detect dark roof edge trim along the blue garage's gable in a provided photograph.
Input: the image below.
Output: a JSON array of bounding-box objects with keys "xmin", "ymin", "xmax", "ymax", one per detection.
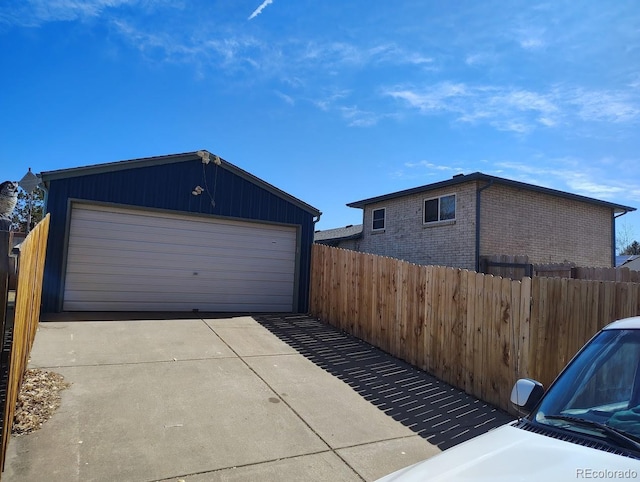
[{"xmin": 40, "ymin": 151, "xmax": 321, "ymax": 216}]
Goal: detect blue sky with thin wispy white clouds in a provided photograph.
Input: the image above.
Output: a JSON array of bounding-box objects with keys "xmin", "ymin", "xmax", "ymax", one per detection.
[{"xmin": 0, "ymin": 0, "xmax": 640, "ymax": 249}]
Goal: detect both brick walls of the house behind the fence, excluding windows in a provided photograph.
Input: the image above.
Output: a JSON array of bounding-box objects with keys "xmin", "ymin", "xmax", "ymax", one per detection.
[{"xmin": 340, "ymin": 182, "xmax": 612, "ymax": 270}]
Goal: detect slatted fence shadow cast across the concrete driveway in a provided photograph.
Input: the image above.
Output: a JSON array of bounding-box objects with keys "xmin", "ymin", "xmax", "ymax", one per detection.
[{"xmin": 253, "ymin": 315, "xmax": 513, "ymax": 450}]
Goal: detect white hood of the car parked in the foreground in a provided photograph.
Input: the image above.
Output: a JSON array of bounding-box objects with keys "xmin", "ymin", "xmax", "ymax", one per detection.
[{"xmin": 380, "ymin": 424, "xmax": 640, "ymax": 482}]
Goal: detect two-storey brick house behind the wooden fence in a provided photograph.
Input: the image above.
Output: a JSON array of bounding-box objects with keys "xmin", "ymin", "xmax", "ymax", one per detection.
[{"xmin": 315, "ymin": 172, "xmax": 635, "ymax": 271}]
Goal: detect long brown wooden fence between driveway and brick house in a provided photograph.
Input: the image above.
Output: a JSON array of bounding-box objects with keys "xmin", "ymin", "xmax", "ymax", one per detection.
[{"xmin": 310, "ymin": 244, "xmax": 640, "ymax": 411}]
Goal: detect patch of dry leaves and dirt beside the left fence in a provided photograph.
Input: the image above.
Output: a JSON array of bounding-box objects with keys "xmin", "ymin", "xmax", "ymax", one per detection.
[{"xmin": 11, "ymin": 369, "xmax": 70, "ymax": 435}]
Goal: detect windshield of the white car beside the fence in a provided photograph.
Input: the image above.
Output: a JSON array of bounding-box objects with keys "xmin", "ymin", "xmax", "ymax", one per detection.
[{"xmin": 530, "ymin": 329, "xmax": 640, "ymax": 449}]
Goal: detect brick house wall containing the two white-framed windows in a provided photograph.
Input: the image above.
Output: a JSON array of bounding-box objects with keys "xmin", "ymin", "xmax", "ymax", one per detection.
[{"xmin": 356, "ymin": 183, "xmax": 475, "ymax": 269}]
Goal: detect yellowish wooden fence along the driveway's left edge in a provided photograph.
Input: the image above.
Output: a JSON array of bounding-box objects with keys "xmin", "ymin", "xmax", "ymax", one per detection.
[{"xmin": 0, "ymin": 215, "xmax": 49, "ymax": 470}]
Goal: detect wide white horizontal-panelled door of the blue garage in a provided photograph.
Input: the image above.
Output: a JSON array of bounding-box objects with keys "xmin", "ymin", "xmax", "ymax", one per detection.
[{"xmin": 63, "ymin": 204, "xmax": 297, "ymax": 312}]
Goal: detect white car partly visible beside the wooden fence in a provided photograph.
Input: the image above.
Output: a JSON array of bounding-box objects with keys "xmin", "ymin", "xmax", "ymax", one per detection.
[{"xmin": 380, "ymin": 317, "xmax": 640, "ymax": 482}]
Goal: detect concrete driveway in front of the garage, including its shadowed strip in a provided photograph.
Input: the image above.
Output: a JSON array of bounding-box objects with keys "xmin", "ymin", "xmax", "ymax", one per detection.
[{"xmin": 2, "ymin": 315, "xmax": 508, "ymax": 482}]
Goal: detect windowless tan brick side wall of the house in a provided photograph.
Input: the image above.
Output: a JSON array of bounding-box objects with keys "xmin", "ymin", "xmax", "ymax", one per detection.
[{"xmin": 480, "ymin": 185, "xmax": 612, "ymax": 267}]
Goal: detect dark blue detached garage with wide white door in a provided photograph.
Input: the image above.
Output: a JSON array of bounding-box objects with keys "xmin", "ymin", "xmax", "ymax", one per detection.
[{"xmin": 42, "ymin": 151, "xmax": 320, "ymax": 313}]
